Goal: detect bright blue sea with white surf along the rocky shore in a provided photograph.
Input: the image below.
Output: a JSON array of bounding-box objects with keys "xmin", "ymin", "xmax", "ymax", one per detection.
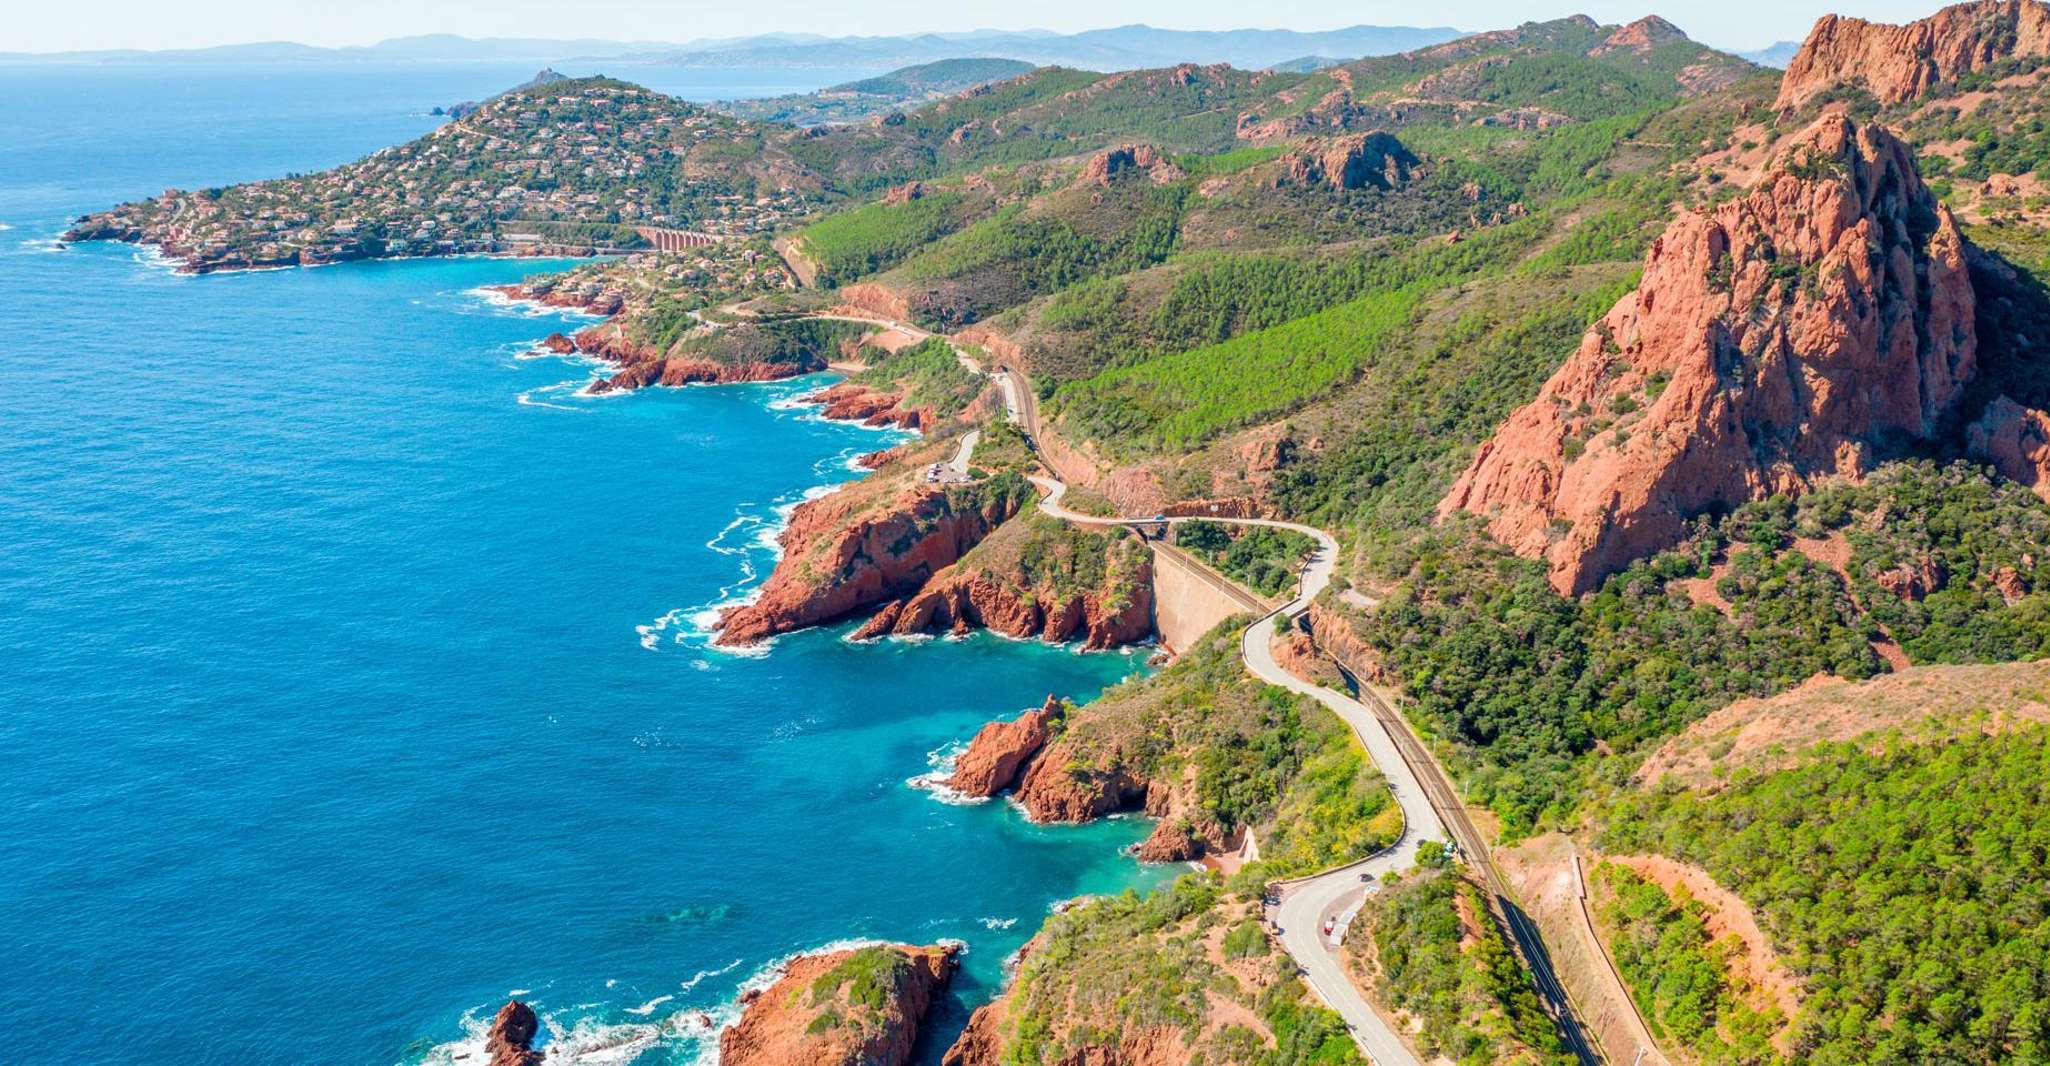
[{"xmin": 0, "ymin": 68, "xmax": 1166, "ymax": 1064}]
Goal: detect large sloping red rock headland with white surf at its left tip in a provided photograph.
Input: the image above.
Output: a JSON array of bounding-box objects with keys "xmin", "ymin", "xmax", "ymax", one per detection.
[{"xmin": 718, "ymin": 488, "xmax": 1019, "ymax": 644}]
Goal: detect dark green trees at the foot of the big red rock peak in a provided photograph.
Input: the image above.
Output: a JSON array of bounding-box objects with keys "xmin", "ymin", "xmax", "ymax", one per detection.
[{"xmin": 1363, "ymin": 463, "xmax": 2050, "ymax": 836}]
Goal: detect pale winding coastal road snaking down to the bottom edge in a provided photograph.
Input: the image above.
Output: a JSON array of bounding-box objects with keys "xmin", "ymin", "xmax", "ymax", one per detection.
[{"xmin": 1031, "ymin": 478, "xmax": 1445, "ymax": 1066}]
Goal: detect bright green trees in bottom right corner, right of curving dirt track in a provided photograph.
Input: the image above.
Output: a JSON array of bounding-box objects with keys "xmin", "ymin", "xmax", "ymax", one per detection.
[{"xmin": 1601, "ymin": 728, "xmax": 2050, "ymax": 1066}]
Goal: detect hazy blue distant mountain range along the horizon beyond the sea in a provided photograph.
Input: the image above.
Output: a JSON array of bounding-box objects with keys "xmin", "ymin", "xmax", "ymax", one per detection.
[{"xmin": 0, "ymin": 25, "xmax": 1462, "ymax": 70}]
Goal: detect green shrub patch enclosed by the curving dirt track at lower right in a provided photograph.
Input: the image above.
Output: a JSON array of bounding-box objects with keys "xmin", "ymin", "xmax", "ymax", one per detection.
[{"xmin": 1595, "ymin": 863, "xmax": 1786, "ymax": 1066}]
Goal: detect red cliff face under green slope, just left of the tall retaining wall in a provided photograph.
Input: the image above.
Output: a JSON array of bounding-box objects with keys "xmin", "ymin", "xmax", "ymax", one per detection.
[{"xmin": 853, "ymin": 566, "xmax": 1152, "ymax": 650}]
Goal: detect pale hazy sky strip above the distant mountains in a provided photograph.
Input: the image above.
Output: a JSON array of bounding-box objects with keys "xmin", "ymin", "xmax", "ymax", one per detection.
[{"xmin": 0, "ymin": 0, "xmax": 1941, "ymax": 51}]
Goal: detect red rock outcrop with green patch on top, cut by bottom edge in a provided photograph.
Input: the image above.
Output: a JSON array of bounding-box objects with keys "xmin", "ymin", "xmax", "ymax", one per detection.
[{"xmin": 720, "ymin": 945, "xmax": 959, "ymax": 1066}]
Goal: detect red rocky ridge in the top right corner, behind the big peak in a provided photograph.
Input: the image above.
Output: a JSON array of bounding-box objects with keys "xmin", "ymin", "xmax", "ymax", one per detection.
[{"xmin": 1775, "ymin": 0, "xmax": 2050, "ymax": 111}]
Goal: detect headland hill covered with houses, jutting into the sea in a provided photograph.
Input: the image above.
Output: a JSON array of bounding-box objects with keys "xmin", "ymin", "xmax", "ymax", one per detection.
[{"xmin": 66, "ymin": 78, "xmax": 818, "ymax": 271}]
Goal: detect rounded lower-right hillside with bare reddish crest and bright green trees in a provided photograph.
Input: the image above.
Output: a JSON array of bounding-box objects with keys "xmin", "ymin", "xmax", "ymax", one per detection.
[{"xmin": 1599, "ymin": 664, "xmax": 2050, "ymax": 1064}]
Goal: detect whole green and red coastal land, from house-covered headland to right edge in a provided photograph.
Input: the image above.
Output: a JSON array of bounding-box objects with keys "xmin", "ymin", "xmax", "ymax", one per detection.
[{"xmin": 59, "ymin": 10, "xmax": 2050, "ymax": 1066}]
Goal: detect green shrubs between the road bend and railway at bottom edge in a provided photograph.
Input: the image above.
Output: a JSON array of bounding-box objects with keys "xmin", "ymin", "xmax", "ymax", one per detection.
[{"xmin": 1345, "ymin": 869, "xmax": 1574, "ymax": 1066}]
